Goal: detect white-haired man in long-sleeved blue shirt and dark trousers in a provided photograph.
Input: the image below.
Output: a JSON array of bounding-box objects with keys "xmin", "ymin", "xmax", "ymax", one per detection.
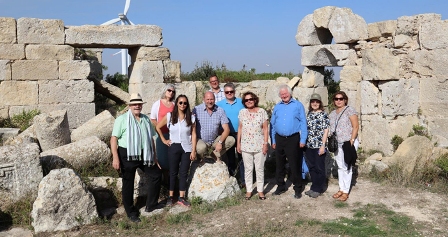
[{"xmin": 271, "ymin": 85, "xmax": 308, "ymax": 199}]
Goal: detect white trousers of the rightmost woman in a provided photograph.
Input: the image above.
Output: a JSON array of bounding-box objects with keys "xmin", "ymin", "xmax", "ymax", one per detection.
[{"xmin": 334, "ymin": 139, "xmax": 359, "ymax": 193}]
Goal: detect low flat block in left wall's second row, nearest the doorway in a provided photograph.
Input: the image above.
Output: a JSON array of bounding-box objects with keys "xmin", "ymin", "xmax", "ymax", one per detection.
[{"xmin": 25, "ymin": 44, "xmax": 75, "ymax": 60}]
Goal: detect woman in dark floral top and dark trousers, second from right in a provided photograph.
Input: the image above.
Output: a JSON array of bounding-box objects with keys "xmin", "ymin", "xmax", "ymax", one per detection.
[{"xmin": 305, "ymin": 93, "xmax": 330, "ymax": 198}]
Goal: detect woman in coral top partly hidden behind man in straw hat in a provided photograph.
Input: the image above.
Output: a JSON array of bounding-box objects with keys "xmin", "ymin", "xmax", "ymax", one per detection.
[{"xmin": 149, "ymin": 84, "xmax": 176, "ymax": 185}]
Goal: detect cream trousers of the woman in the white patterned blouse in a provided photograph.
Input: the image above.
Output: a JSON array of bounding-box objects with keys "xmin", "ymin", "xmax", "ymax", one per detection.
[{"xmin": 241, "ymin": 151, "xmax": 266, "ymax": 193}]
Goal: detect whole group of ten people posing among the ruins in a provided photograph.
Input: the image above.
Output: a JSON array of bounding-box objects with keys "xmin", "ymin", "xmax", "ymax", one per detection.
[{"xmin": 111, "ymin": 76, "xmax": 358, "ymax": 222}]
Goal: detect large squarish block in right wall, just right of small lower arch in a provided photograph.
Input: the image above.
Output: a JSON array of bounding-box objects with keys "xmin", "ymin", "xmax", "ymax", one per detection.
[{"xmin": 362, "ymin": 48, "xmax": 400, "ymax": 80}]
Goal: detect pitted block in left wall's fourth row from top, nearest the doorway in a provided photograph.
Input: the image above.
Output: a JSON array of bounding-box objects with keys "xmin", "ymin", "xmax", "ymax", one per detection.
[{"xmin": 39, "ymin": 80, "xmax": 94, "ymax": 104}]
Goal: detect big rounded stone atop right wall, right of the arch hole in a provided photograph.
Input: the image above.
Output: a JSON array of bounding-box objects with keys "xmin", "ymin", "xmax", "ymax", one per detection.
[{"xmin": 328, "ymin": 7, "xmax": 368, "ymax": 44}]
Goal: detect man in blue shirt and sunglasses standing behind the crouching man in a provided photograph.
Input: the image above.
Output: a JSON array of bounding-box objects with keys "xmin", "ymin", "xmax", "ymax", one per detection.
[{"xmin": 216, "ymin": 83, "xmax": 245, "ymax": 186}]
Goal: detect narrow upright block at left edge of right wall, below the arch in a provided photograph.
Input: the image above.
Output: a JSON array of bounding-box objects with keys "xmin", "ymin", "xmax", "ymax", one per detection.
[{"xmin": 360, "ymin": 81, "xmax": 380, "ymax": 115}]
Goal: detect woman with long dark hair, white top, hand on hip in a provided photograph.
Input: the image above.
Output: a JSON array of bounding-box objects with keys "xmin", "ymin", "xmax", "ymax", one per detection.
[{"xmin": 156, "ymin": 95, "xmax": 196, "ymax": 207}]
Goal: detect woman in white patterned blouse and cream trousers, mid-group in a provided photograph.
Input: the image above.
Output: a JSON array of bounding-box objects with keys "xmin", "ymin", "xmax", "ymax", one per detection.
[{"xmin": 236, "ymin": 91, "xmax": 269, "ymax": 200}]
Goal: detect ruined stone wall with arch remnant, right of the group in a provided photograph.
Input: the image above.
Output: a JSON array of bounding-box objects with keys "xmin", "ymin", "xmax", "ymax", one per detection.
[{"xmin": 296, "ymin": 7, "xmax": 448, "ymax": 155}]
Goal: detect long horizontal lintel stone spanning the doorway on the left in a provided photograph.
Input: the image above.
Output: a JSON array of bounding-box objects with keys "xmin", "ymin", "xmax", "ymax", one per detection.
[{"xmin": 65, "ymin": 25, "xmax": 163, "ymax": 48}]
